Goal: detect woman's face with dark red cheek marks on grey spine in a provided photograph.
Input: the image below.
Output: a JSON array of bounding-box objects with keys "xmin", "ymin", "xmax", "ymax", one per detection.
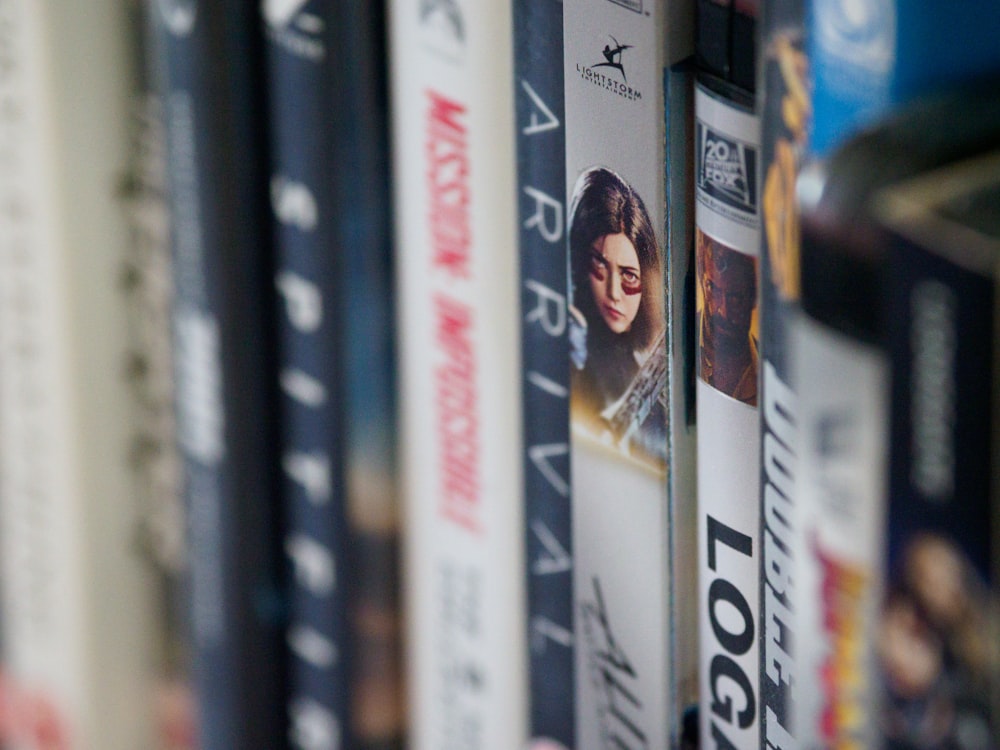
[{"xmin": 590, "ymin": 232, "xmax": 642, "ymax": 333}]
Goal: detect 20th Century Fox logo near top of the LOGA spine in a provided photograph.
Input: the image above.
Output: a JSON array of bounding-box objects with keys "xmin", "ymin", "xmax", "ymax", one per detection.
[{"xmin": 697, "ymin": 121, "xmax": 757, "ymax": 214}]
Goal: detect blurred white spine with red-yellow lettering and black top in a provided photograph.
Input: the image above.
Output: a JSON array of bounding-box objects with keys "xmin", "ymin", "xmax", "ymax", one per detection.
[{"xmin": 789, "ymin": 185, "xmax": 890, "ymax": 747}]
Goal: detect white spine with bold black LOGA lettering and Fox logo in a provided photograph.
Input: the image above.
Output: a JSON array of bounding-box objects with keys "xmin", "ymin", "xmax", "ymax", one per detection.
[{"xmin": 695, "ymin": 74, "xmax": 760, "ymax": 748}]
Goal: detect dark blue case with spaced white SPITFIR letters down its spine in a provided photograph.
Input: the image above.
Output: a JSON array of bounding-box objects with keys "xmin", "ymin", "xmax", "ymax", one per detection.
[{"xmin": 263, "ymin": 0, "xmax": 404, "ymax": 748}]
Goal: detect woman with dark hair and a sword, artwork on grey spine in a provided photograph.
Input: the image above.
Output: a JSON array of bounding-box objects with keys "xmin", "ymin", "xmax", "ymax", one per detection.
[{"xmin": 569, "ymin": 167, "xmax": 667, "ymax": 471}]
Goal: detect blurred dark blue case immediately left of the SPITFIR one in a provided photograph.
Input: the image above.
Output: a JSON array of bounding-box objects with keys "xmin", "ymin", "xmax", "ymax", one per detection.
[{"xmin": 141, "ymin": 0, "xmax": 285, "ymax": 750}]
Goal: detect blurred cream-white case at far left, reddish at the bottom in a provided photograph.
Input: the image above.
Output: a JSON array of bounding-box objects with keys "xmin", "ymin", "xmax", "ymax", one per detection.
[{"xmin": 0, "ymin": 0, "xmax": 159, "ymax": 750}]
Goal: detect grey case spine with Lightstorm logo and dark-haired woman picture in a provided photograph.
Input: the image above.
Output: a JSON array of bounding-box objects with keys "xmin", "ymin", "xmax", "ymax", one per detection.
[{"xmin": 563, "ymin": 0, "xmax": 696, "ymax": 749}]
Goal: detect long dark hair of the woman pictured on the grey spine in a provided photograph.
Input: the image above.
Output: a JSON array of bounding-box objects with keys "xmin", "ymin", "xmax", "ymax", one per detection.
[{"xmin": 569, "ymin": 167, "xmax": 663, "ymax": 350}]
